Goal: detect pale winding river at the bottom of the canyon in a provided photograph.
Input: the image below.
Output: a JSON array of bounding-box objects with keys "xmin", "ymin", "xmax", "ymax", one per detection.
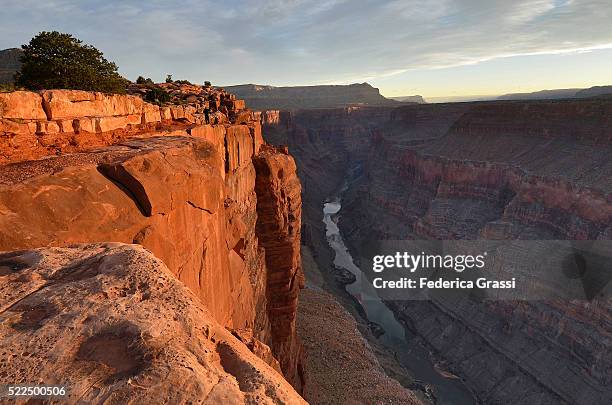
[{"xmin": 323, "ymin": 199, "xmax": 477, "ymax": 405}]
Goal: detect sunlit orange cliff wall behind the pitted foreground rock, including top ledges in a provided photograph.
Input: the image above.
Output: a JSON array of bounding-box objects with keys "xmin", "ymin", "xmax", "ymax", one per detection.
[{"xmin": 0, "ymin": 90, "xmax": 303, "ymax": 390}]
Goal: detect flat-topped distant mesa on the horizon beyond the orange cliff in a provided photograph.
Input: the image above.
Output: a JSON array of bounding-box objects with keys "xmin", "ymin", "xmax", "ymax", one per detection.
[{"xmin": 225, "ymin": 83, "xmax": 416, "ymax": 110}]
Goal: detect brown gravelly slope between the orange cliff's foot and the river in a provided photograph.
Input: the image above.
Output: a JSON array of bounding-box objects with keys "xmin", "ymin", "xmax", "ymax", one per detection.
[{"xmin": 298, "ymin": 246, "xmax": 421, "ymax": 404}]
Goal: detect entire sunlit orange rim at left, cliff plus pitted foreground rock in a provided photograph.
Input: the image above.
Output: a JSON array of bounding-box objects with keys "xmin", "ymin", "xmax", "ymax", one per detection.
[{"xmin": 0, "ymin": 86, "xmax": 304, "ymax": 403}]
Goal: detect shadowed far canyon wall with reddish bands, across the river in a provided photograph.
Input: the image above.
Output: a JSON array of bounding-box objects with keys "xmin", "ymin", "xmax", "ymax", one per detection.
[{"xmin": 272, "ymin": 100, "xmax": 612, "ymax": 404}]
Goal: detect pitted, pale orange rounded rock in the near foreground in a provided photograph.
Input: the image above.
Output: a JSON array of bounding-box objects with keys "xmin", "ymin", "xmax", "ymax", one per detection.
[{"xmin": 0, "ymin": 243, "xmax": 305, "ymax": 404}]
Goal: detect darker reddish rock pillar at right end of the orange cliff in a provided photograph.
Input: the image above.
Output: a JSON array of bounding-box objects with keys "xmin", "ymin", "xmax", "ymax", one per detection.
[{"xmin": 255, "ymin": 147, "xmax": 304, "ymax": 385}]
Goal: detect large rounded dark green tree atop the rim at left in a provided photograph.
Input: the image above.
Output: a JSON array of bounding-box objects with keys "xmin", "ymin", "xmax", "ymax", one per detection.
[{"xmin": 16, "ymin": 31, "xmax": 127, "ymax": 93}]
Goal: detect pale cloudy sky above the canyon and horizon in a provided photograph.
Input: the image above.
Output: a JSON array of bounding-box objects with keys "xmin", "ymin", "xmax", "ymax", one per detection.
[{"xmin": 0, "ymin": 0, "xmax": 612, "ymax": 97}]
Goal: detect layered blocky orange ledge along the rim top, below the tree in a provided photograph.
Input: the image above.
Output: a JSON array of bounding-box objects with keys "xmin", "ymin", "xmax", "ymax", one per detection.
[{"xmin": 0, "ymin": 88, "xmax": 251, "ymax": 164}]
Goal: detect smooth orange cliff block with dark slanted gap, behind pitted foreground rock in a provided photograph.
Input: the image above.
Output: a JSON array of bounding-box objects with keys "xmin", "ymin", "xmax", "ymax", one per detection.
[{"xmin": 0, "ymin": 137, "xmax": 253, "ymax": 328}]
